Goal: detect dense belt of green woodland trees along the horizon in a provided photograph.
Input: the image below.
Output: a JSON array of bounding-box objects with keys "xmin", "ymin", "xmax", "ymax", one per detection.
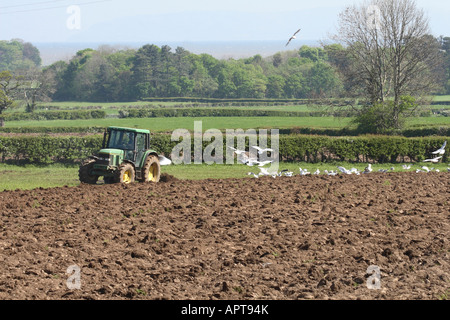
[{"xmin": 0, "ymin": 38, "xmax": 450, "ymax": 102}]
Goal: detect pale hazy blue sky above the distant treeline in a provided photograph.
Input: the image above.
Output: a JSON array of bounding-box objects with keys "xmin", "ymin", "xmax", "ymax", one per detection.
[{"xmin": 0, "ymin": 0, "xmax": 450, "ymax": 43}]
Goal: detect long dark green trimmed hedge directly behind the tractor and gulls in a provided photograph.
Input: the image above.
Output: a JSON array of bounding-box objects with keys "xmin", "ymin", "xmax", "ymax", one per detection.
[{"xmin": 0, "ymin": 134, "xmax": 448, "ymax": 164}]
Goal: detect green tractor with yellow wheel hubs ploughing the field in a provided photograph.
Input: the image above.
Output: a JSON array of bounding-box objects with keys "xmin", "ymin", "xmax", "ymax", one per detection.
[{"xmin": 78, "ymin": 127, "xmax": 161, "ymax": 184}]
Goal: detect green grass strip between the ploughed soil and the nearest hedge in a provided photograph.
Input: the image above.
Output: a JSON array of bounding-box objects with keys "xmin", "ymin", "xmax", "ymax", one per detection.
[{"xmin": 0, "ymin": 162, "xmax": 450, "ymax": 192}]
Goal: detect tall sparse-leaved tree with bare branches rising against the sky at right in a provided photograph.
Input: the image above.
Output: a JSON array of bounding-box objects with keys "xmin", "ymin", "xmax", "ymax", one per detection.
[{"xmin": 335, "ymin": 0, "xmax": 442, "ymax": 129}]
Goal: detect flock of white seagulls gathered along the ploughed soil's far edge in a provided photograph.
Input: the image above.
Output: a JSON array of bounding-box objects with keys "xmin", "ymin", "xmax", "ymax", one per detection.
[{"xmin": 228, "ymin": 141, "xmax": 450, "ymax": 178}]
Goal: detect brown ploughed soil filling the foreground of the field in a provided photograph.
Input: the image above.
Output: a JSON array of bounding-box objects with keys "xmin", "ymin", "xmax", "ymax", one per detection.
[{"xmin": 0, "ymin": 173, "xmax": 450, "ymax": 300}]
